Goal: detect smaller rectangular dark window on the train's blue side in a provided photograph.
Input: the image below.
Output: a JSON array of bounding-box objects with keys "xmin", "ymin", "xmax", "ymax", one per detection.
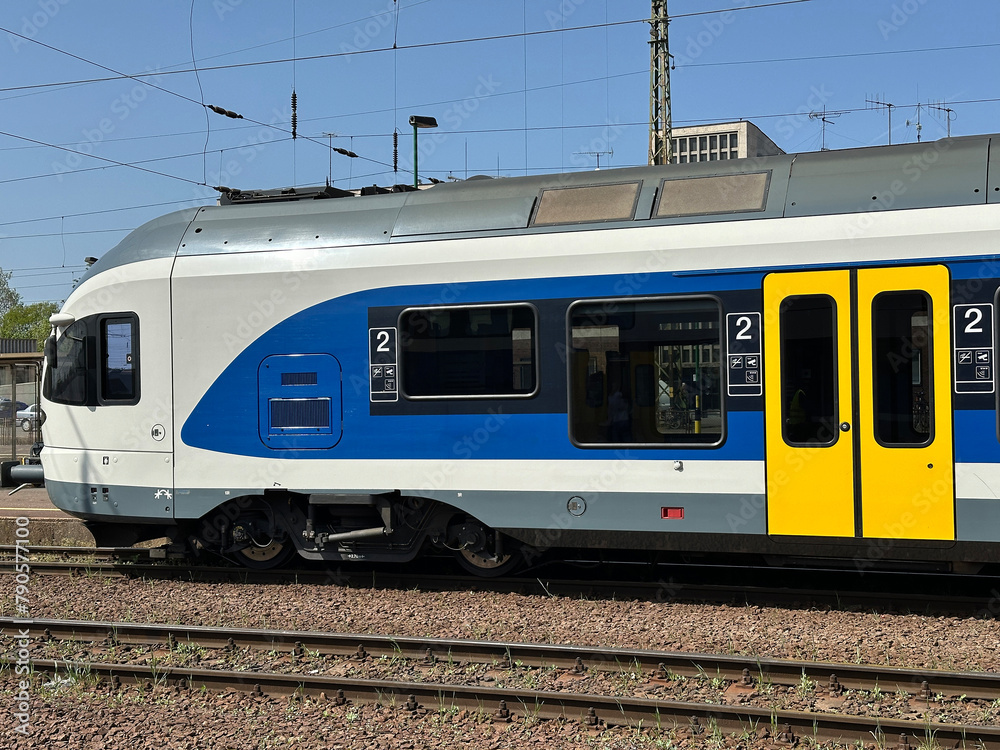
[{"xmin": 399, "ymin": 304, "xmax": 538, "ymax": 399}]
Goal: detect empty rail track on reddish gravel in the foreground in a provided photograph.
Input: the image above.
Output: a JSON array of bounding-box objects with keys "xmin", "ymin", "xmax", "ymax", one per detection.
[{"xmin": 0, "ymin": 619, "xmax": 1000, "ymax": 750}]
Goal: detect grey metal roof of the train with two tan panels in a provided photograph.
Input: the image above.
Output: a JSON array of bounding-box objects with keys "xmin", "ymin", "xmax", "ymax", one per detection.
[{"xmin": 88, "ymin": 135, "xmax": 1000, "ymax": 275}]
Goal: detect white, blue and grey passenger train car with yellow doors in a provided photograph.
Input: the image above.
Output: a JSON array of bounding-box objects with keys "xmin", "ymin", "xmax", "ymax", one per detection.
[{"xmin": 42, "ymin": 136, "xmax": 1000, "ymax": 575}]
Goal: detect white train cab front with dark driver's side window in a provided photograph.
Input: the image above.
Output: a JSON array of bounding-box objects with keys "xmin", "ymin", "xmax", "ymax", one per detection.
[{"xmin": 42, "ymin": 274, "xmax": 176, "ymax": 546}]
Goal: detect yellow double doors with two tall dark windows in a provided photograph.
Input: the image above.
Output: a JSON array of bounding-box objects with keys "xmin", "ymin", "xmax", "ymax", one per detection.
[{"xmin": 764, "ymin": 266, "xmax": 955, "ymax": 540}]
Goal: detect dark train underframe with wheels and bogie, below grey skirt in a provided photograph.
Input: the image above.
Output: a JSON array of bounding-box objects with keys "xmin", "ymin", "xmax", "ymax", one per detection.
[{"xmin": 80, "ymin": 490, "xmax": 1000, "ymax": 577}]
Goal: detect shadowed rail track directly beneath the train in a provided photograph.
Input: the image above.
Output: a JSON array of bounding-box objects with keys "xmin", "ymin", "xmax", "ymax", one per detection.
[{"xmin": 0, "ymin": 546, "xmax": 1000, "ymax": 616}]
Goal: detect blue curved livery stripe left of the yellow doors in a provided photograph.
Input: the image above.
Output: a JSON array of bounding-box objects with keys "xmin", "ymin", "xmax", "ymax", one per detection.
[{"xmin": 181, "ymin": 274, "xmax": 764, "ymax": 460}]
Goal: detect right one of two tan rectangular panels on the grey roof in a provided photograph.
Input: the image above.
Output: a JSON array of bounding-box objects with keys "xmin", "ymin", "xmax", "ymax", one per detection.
[{"xmin": 655, "ymin": 172, "xmax": 771, "ymax": 219}]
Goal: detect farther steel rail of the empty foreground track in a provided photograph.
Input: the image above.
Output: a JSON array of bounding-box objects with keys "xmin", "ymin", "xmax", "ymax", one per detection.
[{"xmin": 0, "ymin": 618, "xmax": 1000, "ymax": 701}]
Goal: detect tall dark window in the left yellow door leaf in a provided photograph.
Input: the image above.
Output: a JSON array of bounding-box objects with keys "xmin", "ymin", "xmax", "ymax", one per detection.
[{"xmin": 779, "ymin": 294, "xmax": 840, "ymax": 446}]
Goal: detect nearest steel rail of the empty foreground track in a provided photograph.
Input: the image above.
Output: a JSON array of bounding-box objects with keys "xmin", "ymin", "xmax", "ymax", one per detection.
[{"xmin": 7, "ymin": 658, "xmax": 1000, "ymax": 750}]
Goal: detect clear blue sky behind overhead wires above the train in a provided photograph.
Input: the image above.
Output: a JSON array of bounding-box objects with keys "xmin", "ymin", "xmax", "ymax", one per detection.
[{"xmin": 0, "ymin": 0, "xmax": 1000, "ymax": 302}]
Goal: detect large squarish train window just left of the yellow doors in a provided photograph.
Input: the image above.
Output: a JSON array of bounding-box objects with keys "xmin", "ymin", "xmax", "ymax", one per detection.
[{"xmin": 569, "ymin": 298, "xmax": 724, "ymax": 448}]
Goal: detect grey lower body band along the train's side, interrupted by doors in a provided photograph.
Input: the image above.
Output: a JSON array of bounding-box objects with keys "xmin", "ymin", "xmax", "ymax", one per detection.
[{"xmin": 46, "ymin": 481, "xmax": 1000, "ymax": 568}]
